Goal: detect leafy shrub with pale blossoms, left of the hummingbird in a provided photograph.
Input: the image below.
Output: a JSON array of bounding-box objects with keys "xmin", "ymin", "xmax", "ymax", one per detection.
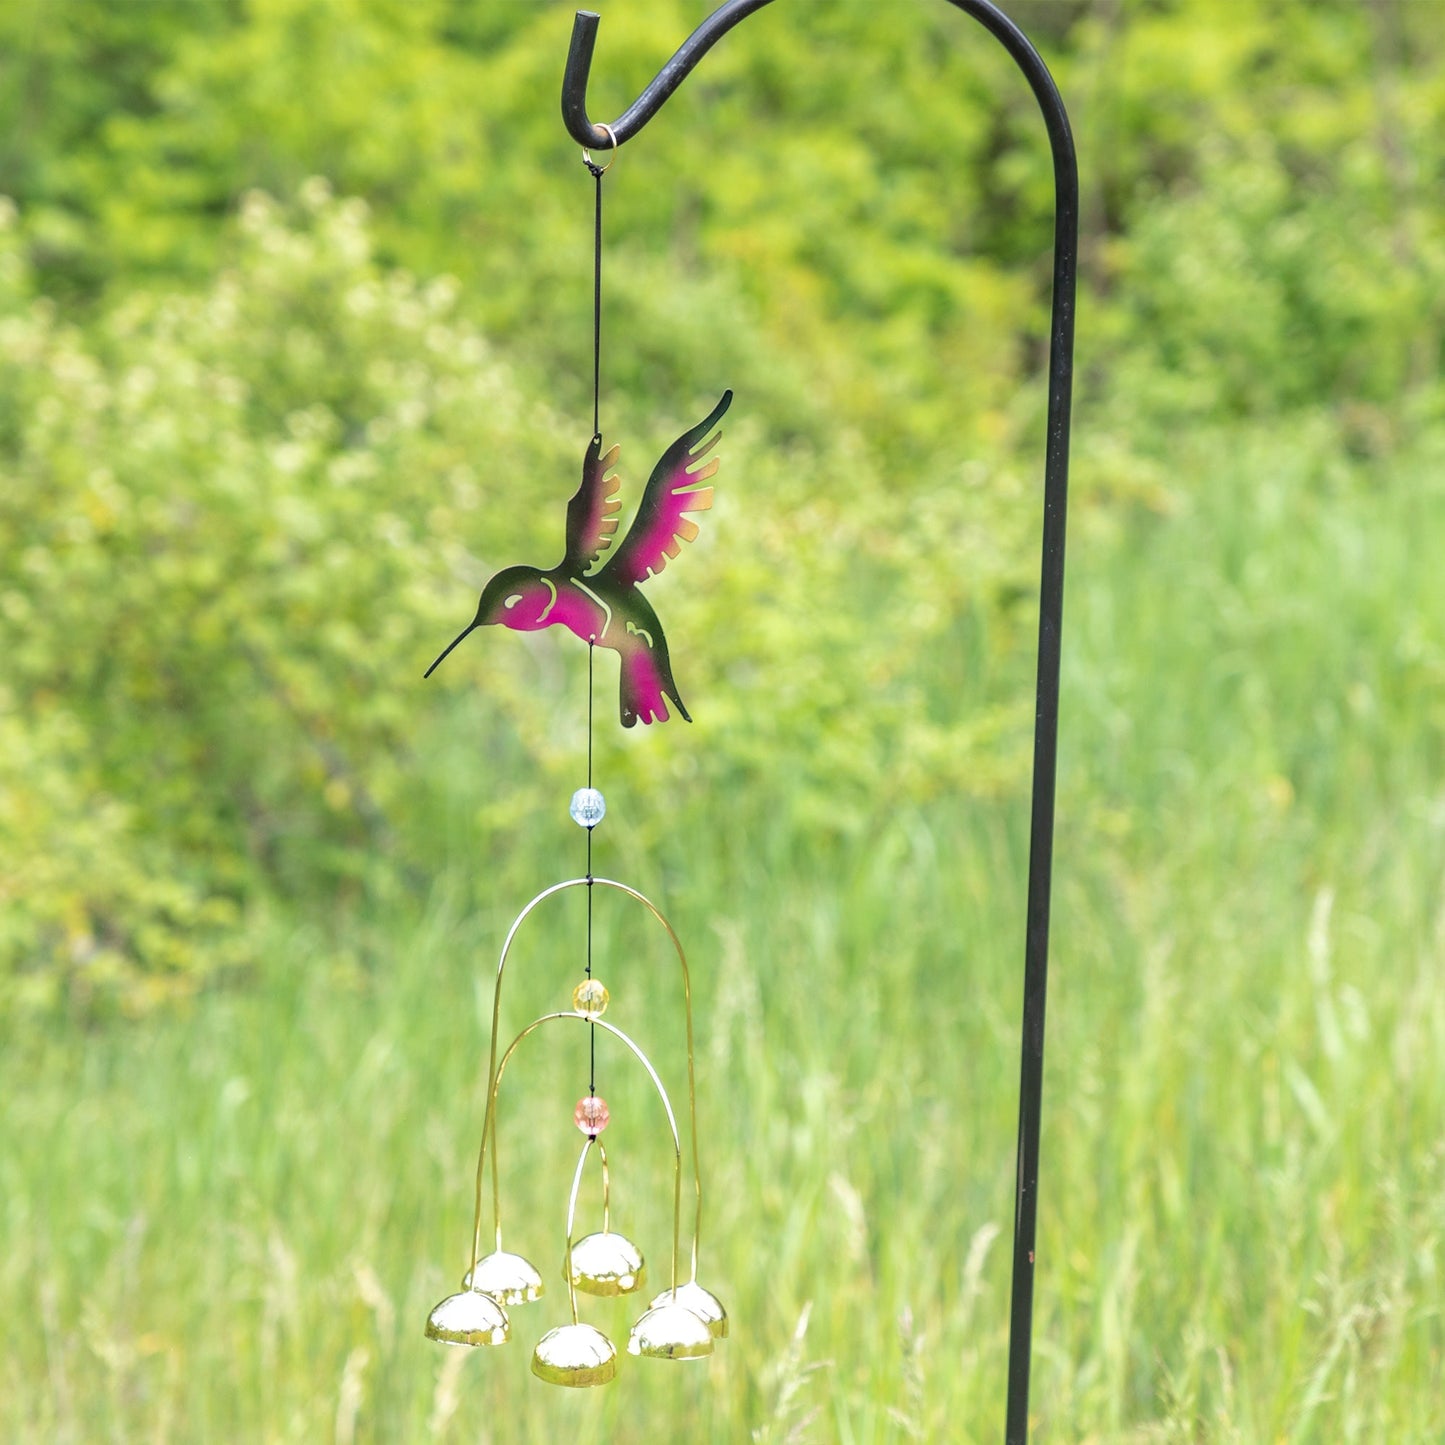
[{"xmin": 0, "ymin": 184, "xmax": 566, "ymax": 1003}]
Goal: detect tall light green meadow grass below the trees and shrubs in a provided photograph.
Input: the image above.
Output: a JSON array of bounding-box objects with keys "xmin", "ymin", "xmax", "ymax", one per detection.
[{"xmin": 0, "ymin": 413, "xmax": 1445, "ymax": 1445}]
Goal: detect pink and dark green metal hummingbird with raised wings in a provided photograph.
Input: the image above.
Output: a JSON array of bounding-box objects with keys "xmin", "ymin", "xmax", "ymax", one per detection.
[{"xmin": 426, "ymin": 392, "xmax": 733, "ymax": 727}]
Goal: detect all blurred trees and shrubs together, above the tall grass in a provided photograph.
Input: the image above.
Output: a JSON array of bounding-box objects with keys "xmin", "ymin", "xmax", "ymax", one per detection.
[{"xmin": 0, "ymin": 0, "xmax": 1445, "ymax": 1007}]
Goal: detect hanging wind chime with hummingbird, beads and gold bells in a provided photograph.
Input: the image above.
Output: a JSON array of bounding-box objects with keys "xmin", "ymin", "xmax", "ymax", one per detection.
[{"xmin": 426, "ymin": 127, "xmax": 733, "ymax": 1386}]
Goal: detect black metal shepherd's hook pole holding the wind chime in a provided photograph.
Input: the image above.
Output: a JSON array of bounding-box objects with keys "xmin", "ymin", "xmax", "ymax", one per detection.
[{"xmin": 562, "ymin": 0, "xmax": 1079, "ymax": 1445}]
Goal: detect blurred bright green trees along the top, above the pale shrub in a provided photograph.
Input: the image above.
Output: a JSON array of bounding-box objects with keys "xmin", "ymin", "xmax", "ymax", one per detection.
[{"xmin": 3, "ymin": 0, "xmax": 1445, "ymax": 444}]
